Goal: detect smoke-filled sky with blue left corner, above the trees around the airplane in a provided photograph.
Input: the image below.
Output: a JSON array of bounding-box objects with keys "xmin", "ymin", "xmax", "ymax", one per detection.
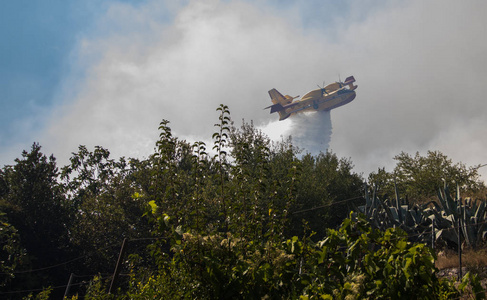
[{"xmin": 0, "ymin": 0, "xmax": 487, "ymax": 179}]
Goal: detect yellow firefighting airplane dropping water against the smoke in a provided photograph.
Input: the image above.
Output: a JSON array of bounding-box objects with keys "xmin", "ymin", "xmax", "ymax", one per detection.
[{"xmin": 264, "ymin": 76, "xmax": 357, "ymax": 121}]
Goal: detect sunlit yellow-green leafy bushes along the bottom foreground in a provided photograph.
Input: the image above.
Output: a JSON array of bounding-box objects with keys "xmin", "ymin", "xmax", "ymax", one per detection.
[{"xmin": 105, "ymin": 215, "xmax": 468, "ymax": 299}]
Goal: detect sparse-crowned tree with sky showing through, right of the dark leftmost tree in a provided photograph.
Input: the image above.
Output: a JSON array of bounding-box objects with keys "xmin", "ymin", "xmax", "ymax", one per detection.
[{"xmin": 62, "ymin": 146, "xmax": 150, "ymax": 273}]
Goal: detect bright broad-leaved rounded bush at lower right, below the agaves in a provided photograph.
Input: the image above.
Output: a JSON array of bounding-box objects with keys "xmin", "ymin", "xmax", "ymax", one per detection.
[{"xmin": 307, "ymin": 215, "xmax": 462, "ymax": 299}]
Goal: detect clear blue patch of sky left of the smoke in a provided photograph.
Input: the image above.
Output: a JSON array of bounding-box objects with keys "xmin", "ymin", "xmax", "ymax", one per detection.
[{"xmin": 0, "ymin": 0, "xmax": 96, "ymax": 148}]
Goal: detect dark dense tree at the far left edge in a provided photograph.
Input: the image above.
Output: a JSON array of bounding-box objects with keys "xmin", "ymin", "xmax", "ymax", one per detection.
[{"xmin": 3, "ymin": 143, "xmax": 69, "ymax": 258}]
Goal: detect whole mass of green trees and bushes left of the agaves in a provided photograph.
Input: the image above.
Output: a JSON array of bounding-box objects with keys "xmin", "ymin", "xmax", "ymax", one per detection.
[{"xmin": 0, "ymin": 105, "xmax": 479, "ymax": 299}]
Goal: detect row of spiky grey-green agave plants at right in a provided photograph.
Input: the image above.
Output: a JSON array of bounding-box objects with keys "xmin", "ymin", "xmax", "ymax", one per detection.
[{"xmin": 356, "ymin": 185, "xmax": 487, "ymax": 248}]
